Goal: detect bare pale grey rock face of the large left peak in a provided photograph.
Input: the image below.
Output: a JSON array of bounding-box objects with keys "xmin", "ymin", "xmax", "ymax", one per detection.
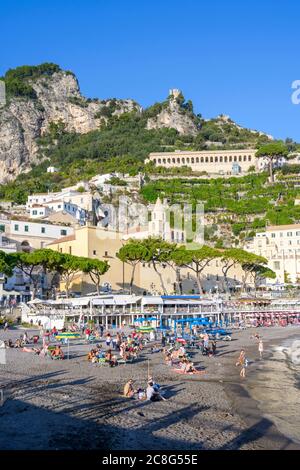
[{"xmin": 0, "ymin": 71, "xmax": 139, "ymax": 182}]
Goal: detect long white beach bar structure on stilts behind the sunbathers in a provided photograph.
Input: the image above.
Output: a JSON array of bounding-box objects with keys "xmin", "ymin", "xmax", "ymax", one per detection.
[{"xmin": 21, "ymin": 294, "xmax": 300, "ymax": 329}]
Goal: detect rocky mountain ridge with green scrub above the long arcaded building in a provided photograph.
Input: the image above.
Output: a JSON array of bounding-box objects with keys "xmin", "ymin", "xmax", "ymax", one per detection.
[{"xmin": 0, "ymin": 63, "xmax": 270, "ymax": 185}]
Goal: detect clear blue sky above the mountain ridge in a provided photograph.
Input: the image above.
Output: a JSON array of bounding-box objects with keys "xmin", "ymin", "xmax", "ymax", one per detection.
[{"xmin": 0, "ymin": 0, "xmax": 300, "ymax": 142}]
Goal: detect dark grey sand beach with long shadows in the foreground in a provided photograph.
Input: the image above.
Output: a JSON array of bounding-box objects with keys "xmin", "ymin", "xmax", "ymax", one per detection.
[{"xmin": 0, "ymin": 326, "xmax": 300, "ymax": 450}]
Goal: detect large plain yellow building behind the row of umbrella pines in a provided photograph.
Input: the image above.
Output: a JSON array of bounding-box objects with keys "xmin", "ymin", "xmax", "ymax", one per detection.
[{"xmin": 47, "ymin": 226, "xmax": 242, "ymax": 294}]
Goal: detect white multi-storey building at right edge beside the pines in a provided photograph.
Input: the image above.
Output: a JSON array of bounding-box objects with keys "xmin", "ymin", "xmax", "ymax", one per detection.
[{"xmin": 245, "ymin": 224, "xmax": 300, "ymax": 284}]
